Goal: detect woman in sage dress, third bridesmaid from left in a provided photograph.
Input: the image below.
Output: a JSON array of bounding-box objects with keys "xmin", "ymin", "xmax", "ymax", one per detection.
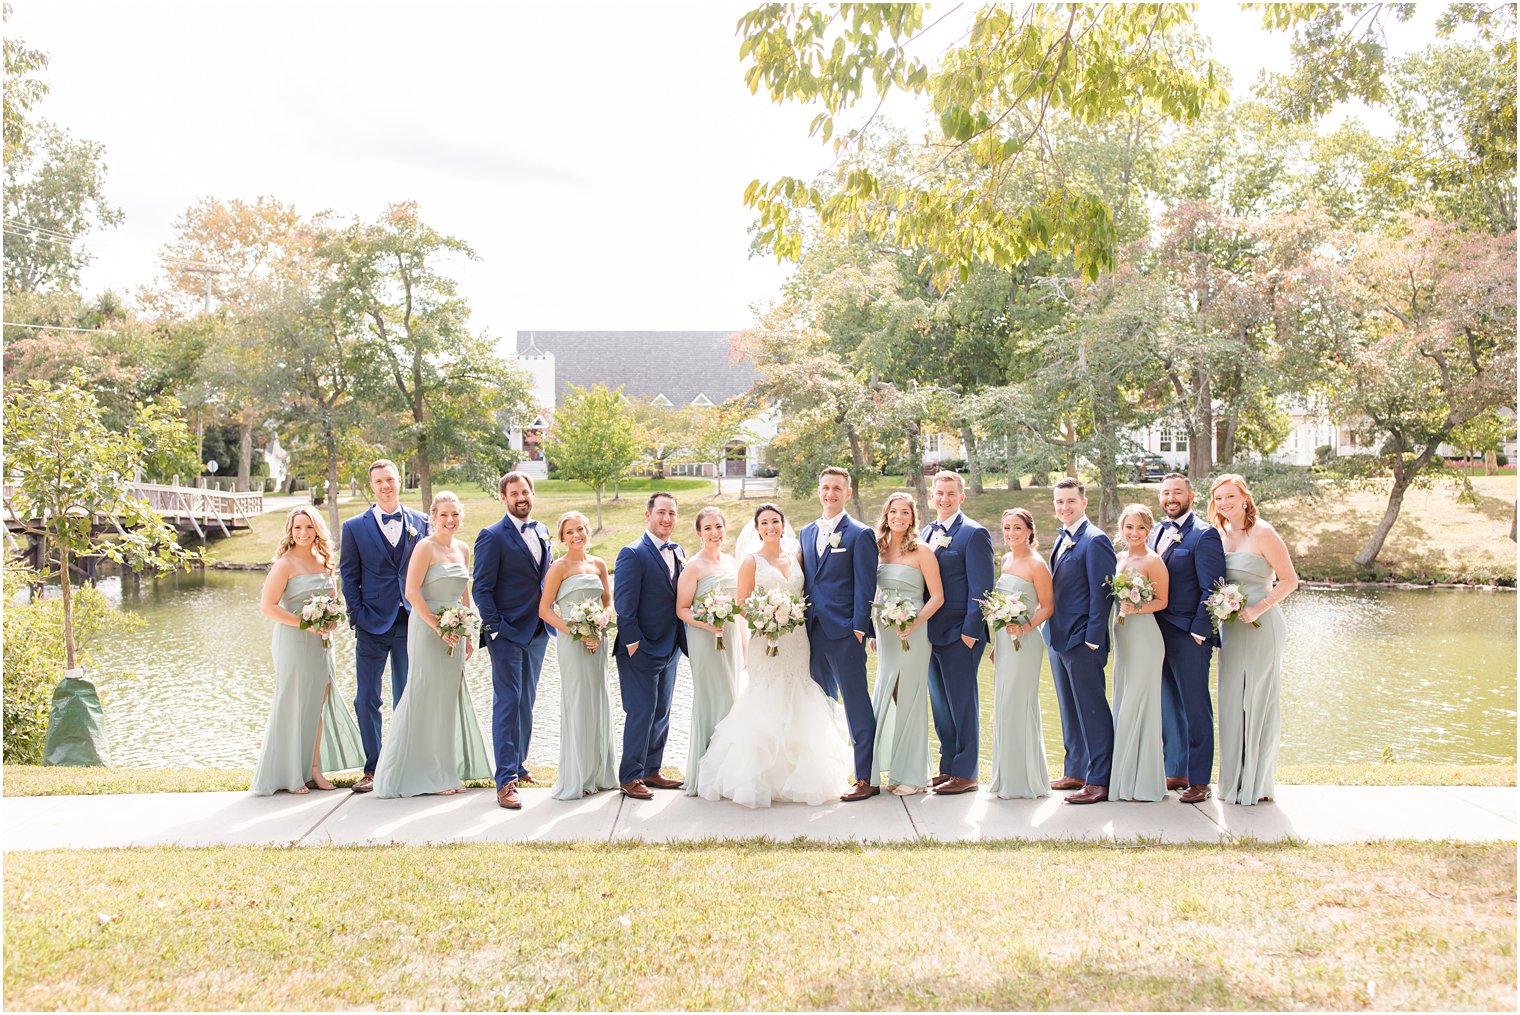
[{"xmin": 538, "ymin": 511, "xmax": 617, "ymax": 801}]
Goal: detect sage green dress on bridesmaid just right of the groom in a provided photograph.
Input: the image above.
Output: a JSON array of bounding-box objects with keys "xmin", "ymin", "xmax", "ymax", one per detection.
[{"xmin": 871, "ymin": 564, "xmax": 930, "ymax": 789}]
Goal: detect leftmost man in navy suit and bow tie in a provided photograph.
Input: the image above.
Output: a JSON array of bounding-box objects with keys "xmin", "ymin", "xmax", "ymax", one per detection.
[{"xmin": 337, "ymin": 459, "xmax": 427, "ymax": 793}]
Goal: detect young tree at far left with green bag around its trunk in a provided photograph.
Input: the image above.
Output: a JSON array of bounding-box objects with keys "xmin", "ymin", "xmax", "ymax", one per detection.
[{"xmin": 5, "ymin": 378, "xmax": 201, "ymax": 669}]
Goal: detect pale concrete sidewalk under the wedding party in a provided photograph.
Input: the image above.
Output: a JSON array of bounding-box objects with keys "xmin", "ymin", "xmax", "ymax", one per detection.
[{"xmin": 0, "ymin": 786, "xmax": 1520, "ymax": 851}]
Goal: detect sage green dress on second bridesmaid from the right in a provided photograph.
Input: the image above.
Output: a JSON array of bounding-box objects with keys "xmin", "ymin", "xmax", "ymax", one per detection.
[{"xmin": 1108, "ymin": 574, "xmax": 1166, "ymax": 801}]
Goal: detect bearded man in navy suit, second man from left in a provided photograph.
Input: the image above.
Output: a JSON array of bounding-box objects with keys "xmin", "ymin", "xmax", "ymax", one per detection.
[{"xmin": 474, "ymin": 473, "xmax": 553, "ymax": 810}]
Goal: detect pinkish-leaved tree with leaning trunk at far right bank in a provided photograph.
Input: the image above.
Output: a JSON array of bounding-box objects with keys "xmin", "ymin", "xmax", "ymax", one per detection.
[{"xmin": 1332, "ymin": 219, "xmax": 1515, "ymax": 568}]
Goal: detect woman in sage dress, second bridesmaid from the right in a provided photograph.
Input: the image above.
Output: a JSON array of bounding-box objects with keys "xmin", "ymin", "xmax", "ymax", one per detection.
[{"xmin": 1108, "ymin": 504, "xmax": 1170, "ymax": 801}]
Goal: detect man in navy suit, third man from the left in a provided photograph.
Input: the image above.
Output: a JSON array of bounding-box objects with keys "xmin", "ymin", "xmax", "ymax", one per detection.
[{"xmin": 613, "ymin": 492, "xmax": 686, "ymax": 801}]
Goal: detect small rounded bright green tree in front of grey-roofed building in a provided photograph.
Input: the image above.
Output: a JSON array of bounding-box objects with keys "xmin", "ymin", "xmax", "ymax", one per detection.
[{"xmin": 544, "ymin": 384, "xmax": 641, "ymax": 532}]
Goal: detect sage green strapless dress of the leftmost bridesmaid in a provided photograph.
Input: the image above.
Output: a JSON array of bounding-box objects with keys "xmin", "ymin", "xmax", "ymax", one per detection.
[{"xmin": 248, "ymin": 574, "xmax": 365, "ymax": 796}]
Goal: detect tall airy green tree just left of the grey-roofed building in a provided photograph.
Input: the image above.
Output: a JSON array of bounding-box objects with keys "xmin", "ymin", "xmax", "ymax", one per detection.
[{"xmin": 324, "ymin": 202, "xmax": 534, "ymax": 501}]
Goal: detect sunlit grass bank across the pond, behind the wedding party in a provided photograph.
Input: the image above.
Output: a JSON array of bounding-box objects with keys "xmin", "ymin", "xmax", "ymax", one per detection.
[{"xmin": 210, "ymin": 476, "xmax": 1515, "ymax": 585}]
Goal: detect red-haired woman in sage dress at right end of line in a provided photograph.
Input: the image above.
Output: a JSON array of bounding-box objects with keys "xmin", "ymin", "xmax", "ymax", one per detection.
[{"xmin": 1208, "ymin": 473, "xmax": 1298, "ymax": 805}]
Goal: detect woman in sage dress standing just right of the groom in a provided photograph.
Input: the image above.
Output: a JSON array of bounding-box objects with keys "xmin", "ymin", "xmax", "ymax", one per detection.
[{"xmin": 871, "ymin": 494, "xmax": 945, "ymax": 796}]
